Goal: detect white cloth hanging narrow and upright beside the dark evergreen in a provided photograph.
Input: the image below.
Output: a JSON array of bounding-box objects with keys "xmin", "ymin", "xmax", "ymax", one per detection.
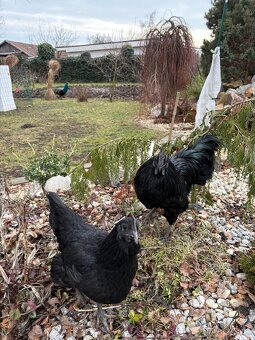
[{"xmin": 195, "ymin": 47, "xmax": 221, "ymax": 128}]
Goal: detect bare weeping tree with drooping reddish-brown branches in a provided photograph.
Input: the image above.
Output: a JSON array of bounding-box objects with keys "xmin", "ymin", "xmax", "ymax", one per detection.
[{"xmin": 141, "ymin": 17, "xmax": 195, "ymax": 133}]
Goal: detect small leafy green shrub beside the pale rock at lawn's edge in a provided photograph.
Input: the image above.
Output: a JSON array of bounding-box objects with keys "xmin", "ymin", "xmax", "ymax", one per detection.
[{"xmin": 24, "ymin": 140, "xmax": 72, "ymax": 186}]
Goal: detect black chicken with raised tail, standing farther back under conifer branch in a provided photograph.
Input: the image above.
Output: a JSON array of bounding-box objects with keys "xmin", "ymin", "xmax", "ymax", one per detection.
[{"xmin": 134, "ymin": 135, "xmax": 220, "ymax": 238}]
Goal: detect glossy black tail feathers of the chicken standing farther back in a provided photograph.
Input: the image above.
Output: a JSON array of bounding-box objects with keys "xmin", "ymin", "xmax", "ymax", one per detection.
[{"xmin": 171, "ymin": 135, "xmax": 221, "ymax": 185}]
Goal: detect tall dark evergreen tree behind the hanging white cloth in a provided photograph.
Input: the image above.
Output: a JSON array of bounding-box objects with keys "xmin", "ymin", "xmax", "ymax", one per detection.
[{"xmin": 201, "ymin": 0, "xmax": 255, "ymax": 82}]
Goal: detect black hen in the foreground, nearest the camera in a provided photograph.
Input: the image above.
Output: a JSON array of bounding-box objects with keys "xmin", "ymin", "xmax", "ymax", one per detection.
[{"xmin": 48, "ymin": 192, "xmax": 140, "ymax": 329}]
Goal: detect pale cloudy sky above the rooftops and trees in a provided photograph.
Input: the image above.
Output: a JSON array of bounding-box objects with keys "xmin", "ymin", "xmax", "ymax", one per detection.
[{"xmin": 0, "ymin": 0, "xmax": 211, "ymax": 47}]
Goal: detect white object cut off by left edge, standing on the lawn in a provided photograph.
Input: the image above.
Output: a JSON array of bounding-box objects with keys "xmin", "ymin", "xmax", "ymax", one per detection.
[{"xmin": 0, "ymin": 65, "xmax": 16, "ymax": 112}]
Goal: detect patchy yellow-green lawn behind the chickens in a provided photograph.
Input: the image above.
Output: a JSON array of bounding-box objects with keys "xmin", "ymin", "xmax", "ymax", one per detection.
[{"xmin": 0, "ymin": 99, "xmax": 163, "ymax": 175}]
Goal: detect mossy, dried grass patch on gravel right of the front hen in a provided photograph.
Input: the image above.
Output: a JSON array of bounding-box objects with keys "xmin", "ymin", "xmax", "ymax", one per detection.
[{"xmin": 132, "ymin": 217, "xmax": 225, "ymax": 306}]
